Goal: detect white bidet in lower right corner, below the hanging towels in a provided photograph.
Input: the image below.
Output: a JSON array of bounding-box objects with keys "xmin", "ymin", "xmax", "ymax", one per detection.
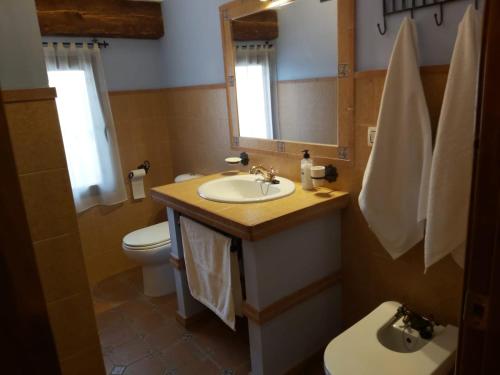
[{"xmin": 324, "ymin": 302, "xmax": 458, "ymax": 375}]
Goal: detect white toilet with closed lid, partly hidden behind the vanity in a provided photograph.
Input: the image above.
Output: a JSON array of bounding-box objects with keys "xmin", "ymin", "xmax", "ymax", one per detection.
[{"xmin": 122, "ymin": 173, "xmax": 201, "ymax": 297}]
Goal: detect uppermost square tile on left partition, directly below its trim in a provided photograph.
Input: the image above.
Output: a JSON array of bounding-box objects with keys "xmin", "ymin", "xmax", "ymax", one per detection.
[{"xmin": 5, "ymin": 100, "xmax": 66, "ymax": 174}]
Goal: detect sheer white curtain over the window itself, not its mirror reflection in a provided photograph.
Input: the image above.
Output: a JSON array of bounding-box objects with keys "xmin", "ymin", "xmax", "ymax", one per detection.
[{"xmin": 44, "ymin": 43, "xmax": 127, "ymax": 212}]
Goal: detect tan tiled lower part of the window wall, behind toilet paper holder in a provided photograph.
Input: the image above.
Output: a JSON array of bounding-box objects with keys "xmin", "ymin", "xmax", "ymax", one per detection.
[{"xmin": 74, "ymin": 90, "xmax": 173, "ymax": 284}]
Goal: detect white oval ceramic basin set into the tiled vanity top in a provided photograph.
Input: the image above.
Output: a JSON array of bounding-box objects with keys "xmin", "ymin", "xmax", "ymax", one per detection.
[{"xmin": 198, "ymin": 175, "xmax": 295, "ymax": 203}]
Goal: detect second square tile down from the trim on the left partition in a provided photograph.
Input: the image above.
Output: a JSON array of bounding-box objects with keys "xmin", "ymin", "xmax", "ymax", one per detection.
[{"xmin": 20, "ymin": 169, "xmax": 76, "ymax": 242}]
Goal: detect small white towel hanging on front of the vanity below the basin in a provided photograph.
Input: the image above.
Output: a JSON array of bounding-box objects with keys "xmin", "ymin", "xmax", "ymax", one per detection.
[{"xmin": 180, "ymin": 216, "xmax": 243, "ymax": 330}]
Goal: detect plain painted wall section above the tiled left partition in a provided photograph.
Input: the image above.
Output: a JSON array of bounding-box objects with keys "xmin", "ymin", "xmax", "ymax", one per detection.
[{"xmin": 0, "ymin": 0, "xmax": 48, "ymax": 90}]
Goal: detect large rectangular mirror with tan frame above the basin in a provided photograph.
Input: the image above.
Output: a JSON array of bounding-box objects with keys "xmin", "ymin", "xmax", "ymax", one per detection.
[{"xmin": 221, "ymin": 0, "xmax": 354, "ymax": 159}]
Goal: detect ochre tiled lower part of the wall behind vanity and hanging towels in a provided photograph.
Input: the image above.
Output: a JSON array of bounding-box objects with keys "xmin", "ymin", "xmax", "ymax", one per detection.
[{"xmin": 162, "ymin": 73, "xmax": 463, "ymax": 325}]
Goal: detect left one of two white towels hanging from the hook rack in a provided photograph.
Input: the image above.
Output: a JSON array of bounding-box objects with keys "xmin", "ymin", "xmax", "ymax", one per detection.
[{"xmin": 359, "ymin": 17, "xmax": 432, "ymax": 259}]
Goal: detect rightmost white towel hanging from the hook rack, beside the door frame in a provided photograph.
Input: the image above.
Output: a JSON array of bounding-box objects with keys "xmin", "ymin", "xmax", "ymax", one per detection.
[{"xmin": 425, "ymin": 6, "xmax": 482, "ymax": 269}]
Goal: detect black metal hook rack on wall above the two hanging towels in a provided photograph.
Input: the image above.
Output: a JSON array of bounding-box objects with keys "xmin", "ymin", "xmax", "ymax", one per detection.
[{"xmin": 377, "ymin": 0, "xmax": 479, "ymax": 35}]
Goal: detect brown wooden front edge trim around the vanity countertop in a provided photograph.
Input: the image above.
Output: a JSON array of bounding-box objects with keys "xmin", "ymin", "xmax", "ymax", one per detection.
[{"xmin": 151, "ymin": 189, "xmax": 350, "ymax": 241}]
